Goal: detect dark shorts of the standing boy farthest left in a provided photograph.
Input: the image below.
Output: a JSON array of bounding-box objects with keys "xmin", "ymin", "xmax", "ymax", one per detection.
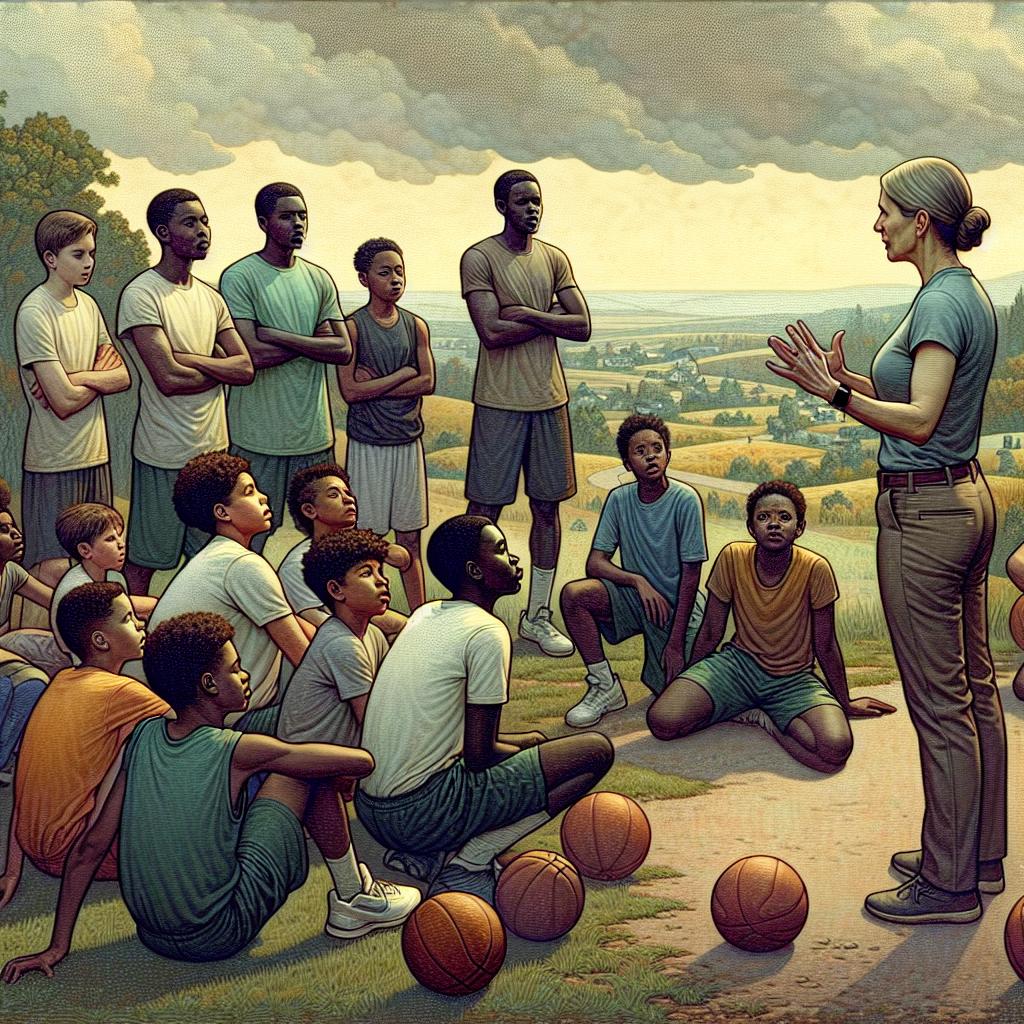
[{"xmin": 22, "ymin": 462, "xmax": 114, "ymax": 568}]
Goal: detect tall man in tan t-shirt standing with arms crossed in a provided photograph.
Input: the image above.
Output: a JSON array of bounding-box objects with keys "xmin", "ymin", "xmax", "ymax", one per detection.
[{"xmin": 460, "ymin": 170, "xmax": 590, "ymax": 657}]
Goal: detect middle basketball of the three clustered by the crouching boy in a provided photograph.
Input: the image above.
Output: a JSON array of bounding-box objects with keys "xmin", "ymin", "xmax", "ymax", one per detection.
[{"xmin": 495, "ymin": 850, "xmax": 585, "ymax": 942}]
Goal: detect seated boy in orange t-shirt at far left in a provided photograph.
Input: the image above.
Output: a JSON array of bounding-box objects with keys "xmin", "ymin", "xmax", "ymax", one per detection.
[{"xmin": 0, "ymin": 583, "xmax": 169, "ymax": 907}]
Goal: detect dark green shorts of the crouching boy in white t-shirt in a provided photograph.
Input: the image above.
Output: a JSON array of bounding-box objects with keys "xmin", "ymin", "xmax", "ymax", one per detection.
[{"xmin": 355, "ymin": 746, "xmax": 548, "ymax": 853}]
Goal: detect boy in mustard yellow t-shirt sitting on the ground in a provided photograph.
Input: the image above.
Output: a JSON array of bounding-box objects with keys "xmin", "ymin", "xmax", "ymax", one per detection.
[{"xmin": 647, "ymin": 480, "xmax": 896, "ymax": 772}]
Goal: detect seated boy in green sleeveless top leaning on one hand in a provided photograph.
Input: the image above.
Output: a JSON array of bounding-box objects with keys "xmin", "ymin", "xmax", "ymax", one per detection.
[{"xmin": 3, "ymin": 612, "xmax": 419, "ymax": 982}]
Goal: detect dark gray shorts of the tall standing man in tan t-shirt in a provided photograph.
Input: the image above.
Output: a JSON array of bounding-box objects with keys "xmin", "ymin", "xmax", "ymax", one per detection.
[{"xmin": 466, "ymin": 406, "xmax": 575, "ymax": 505}]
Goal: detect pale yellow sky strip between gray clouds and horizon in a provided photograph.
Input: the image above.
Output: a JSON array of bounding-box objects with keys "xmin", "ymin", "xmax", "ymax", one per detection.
[{"xmin": 100, "ymin": 141, "xmax": 1024, "ymax": 292}]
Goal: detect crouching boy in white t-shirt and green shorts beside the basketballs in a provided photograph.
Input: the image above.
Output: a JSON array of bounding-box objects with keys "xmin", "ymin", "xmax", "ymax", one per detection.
[{"xmin": 355, "ymin": 515, "xmax": 614, "ymax": 902}]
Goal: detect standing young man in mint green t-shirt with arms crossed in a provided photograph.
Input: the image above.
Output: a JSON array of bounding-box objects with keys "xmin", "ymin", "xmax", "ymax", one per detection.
[{"xmin": 220, "ymin": 181, "xmax": 352, "ymax": 552}]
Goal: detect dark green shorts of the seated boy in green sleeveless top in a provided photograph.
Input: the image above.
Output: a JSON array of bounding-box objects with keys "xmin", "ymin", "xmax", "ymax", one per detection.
[{"xmin": 138, "ymin": 798, "xmax": 309, "ymax": 962}]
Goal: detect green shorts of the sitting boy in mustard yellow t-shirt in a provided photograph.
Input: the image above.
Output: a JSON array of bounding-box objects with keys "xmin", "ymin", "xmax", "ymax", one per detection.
[{"xmin": 682, "ymin": 643, "xmax": 841, "ymax": 732}]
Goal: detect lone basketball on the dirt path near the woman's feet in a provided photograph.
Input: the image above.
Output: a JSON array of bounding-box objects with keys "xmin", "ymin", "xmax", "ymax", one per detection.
[{"xmin": 711, "ymin": 856, "xmax": 807, "ymax": 953}]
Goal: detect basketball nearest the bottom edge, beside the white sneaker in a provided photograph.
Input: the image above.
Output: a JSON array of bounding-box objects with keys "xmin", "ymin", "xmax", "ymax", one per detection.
[{"xmin": 401, "ymin": 892, "xmax": 505, "ymax": 995}]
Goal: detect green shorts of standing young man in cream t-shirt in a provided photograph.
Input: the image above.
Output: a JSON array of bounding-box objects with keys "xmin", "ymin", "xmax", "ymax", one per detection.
[{"xmin": 128, "ymin": 456, "xmax": 210, "ymax": 569}]
